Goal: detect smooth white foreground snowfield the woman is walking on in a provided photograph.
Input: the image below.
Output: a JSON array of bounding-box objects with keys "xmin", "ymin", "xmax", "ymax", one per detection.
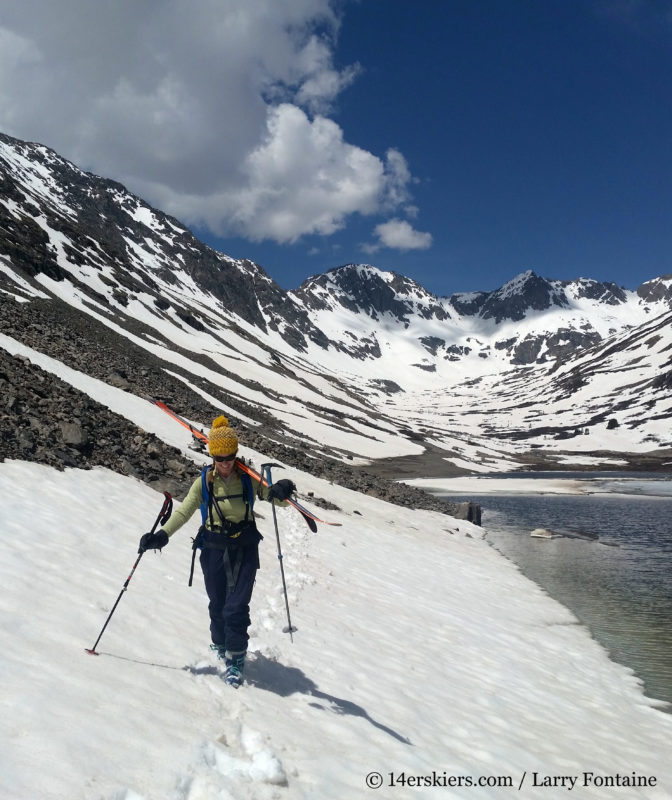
[{"xmin": 0, "ymin": 461, "xmax": 672, "ymax": 800}]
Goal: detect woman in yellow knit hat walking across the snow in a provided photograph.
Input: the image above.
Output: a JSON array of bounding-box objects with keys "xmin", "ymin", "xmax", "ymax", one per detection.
[{"xmin": 138, "ymin": 416, "xmax": 296, "ymax": 688}]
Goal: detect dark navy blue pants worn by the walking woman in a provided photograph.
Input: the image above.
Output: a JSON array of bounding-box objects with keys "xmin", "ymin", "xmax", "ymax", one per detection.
[{"xmin": 200, "ymin": 545, "xmax": 259, "ymax": 653}]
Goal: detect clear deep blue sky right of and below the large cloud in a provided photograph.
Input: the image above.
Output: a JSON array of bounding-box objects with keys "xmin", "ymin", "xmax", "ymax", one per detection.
[{"xmin": 194, "ymin": 0, "xmax": 672, "ymax": 294}]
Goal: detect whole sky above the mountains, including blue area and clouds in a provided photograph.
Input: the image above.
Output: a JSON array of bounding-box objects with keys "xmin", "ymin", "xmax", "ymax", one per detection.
[{"xmin": 0, "ymin": 0, "xmax": 672, "ymax": 294}]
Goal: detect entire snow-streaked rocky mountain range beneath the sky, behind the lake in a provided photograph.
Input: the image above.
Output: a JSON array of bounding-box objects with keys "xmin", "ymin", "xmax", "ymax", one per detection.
[{"xmin": 0, "ymin": 127, "xmax": 672, "ymax": 477}]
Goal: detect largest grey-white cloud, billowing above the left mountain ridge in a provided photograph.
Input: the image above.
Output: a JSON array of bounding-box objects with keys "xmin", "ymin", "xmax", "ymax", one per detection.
[{"xmin": 0, "ymin": 0, "xmax": 420, "ymax": 242}]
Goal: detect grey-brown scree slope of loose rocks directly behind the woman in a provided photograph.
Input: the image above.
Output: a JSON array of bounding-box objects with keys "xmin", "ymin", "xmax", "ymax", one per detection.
[{"xmin": 0, "ymin": 298, "xmax": 476, "ymax": 517}]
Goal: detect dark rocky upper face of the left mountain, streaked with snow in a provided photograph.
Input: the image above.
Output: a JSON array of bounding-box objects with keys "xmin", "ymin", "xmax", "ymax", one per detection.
[{"xmin": 0, "ymin": 134, "xmax": 324, "ymax": 349}]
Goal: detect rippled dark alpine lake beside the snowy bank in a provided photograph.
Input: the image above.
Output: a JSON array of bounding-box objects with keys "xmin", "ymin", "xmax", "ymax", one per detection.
[{"xmin": 443, "ymin": 472, "xmax": 672, "ymax": 713}]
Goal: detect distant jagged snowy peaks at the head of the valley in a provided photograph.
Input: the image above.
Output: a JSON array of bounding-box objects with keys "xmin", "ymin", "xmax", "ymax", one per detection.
[{"xmin": 292, "ymin": 264, "xmax": 672, "ymax": 373}]
